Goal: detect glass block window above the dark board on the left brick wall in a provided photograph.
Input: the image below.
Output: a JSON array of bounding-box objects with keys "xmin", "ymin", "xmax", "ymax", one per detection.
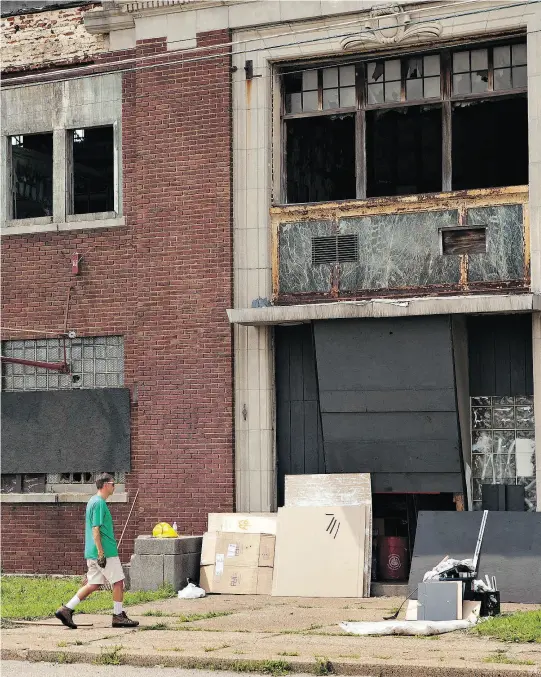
[{"xmin": 2, "ymin": 336, "xmax": 124, "ymax": 391}]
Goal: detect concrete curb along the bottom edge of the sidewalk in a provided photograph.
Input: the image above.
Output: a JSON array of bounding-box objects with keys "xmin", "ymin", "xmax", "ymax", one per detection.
[{"xmin": 1, "ymin": 649, "xmax": 541, "ymax": 677}]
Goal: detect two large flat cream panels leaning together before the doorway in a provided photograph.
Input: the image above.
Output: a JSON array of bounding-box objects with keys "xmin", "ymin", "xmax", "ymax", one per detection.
[{"xmin": 272, "ymin": 473, "xmax": 372, "ymax": 597}]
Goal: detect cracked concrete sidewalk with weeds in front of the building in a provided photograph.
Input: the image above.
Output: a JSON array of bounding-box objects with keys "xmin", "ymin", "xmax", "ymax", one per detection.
[{"xmin": 2, "ymin": 595, "xmax": 541, "ymax": 677}]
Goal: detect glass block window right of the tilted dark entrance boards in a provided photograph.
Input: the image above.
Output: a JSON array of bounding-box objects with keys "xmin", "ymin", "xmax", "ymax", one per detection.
[{"xmin": 471, "ymin": 397, "xmax": 537, "ymax": 512}]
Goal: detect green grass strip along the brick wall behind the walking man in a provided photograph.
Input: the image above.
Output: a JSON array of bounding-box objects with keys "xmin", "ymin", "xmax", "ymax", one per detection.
[{"xmin": 0, "ymin": 576, "xmax": 176, "ymax": 621}]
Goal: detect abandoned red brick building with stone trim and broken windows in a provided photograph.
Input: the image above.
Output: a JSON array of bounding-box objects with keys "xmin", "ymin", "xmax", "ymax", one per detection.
[{"xmin": 2, "ymin": 0, "xmax": 541, "ymax": 572}]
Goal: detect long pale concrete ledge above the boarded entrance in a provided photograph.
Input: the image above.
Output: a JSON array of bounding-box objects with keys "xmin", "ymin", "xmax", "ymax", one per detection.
[{"xmin": 227, "ymin": 294, "xmax": 541, "ymax": 326}]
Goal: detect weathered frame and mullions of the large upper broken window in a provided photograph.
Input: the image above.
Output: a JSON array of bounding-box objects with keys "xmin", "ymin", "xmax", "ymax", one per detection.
[{"xmin": 273, "ymin": 33, "xmax": 528, "ymax": 205}]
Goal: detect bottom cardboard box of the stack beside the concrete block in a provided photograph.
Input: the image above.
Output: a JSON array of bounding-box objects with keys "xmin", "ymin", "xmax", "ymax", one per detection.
[{"xmin": 199, "ymin": 565, "xmax": 273, "ymax": 595}]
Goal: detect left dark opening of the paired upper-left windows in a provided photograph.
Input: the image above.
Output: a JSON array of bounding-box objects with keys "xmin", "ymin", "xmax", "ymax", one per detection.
[{"xmin": 11, "ymin": 134, "xmax": 53, "ymax": 219}]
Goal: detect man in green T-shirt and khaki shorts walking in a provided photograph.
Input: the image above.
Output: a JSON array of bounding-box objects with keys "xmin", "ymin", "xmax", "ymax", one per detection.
[{"xmin": 55, "ymin": 473, "xmax": 139, "ymax": 628}]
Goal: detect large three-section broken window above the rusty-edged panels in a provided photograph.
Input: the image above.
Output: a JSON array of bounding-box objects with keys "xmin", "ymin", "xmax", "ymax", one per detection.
[{"xmin": 283, "ymin": 39, "xmax": 528, "ymax": 203}]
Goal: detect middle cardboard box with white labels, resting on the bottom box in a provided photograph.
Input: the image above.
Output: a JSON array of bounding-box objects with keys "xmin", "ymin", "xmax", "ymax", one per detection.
[{"xmin": 201, "ymin": 531, "xmax": 276, "ymax": 567}]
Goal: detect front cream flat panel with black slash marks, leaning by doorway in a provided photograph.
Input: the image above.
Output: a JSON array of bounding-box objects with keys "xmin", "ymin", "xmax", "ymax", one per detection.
[{"xmin": 272, "ymin": 505, "xmax": 364, "ymax": 597}]
